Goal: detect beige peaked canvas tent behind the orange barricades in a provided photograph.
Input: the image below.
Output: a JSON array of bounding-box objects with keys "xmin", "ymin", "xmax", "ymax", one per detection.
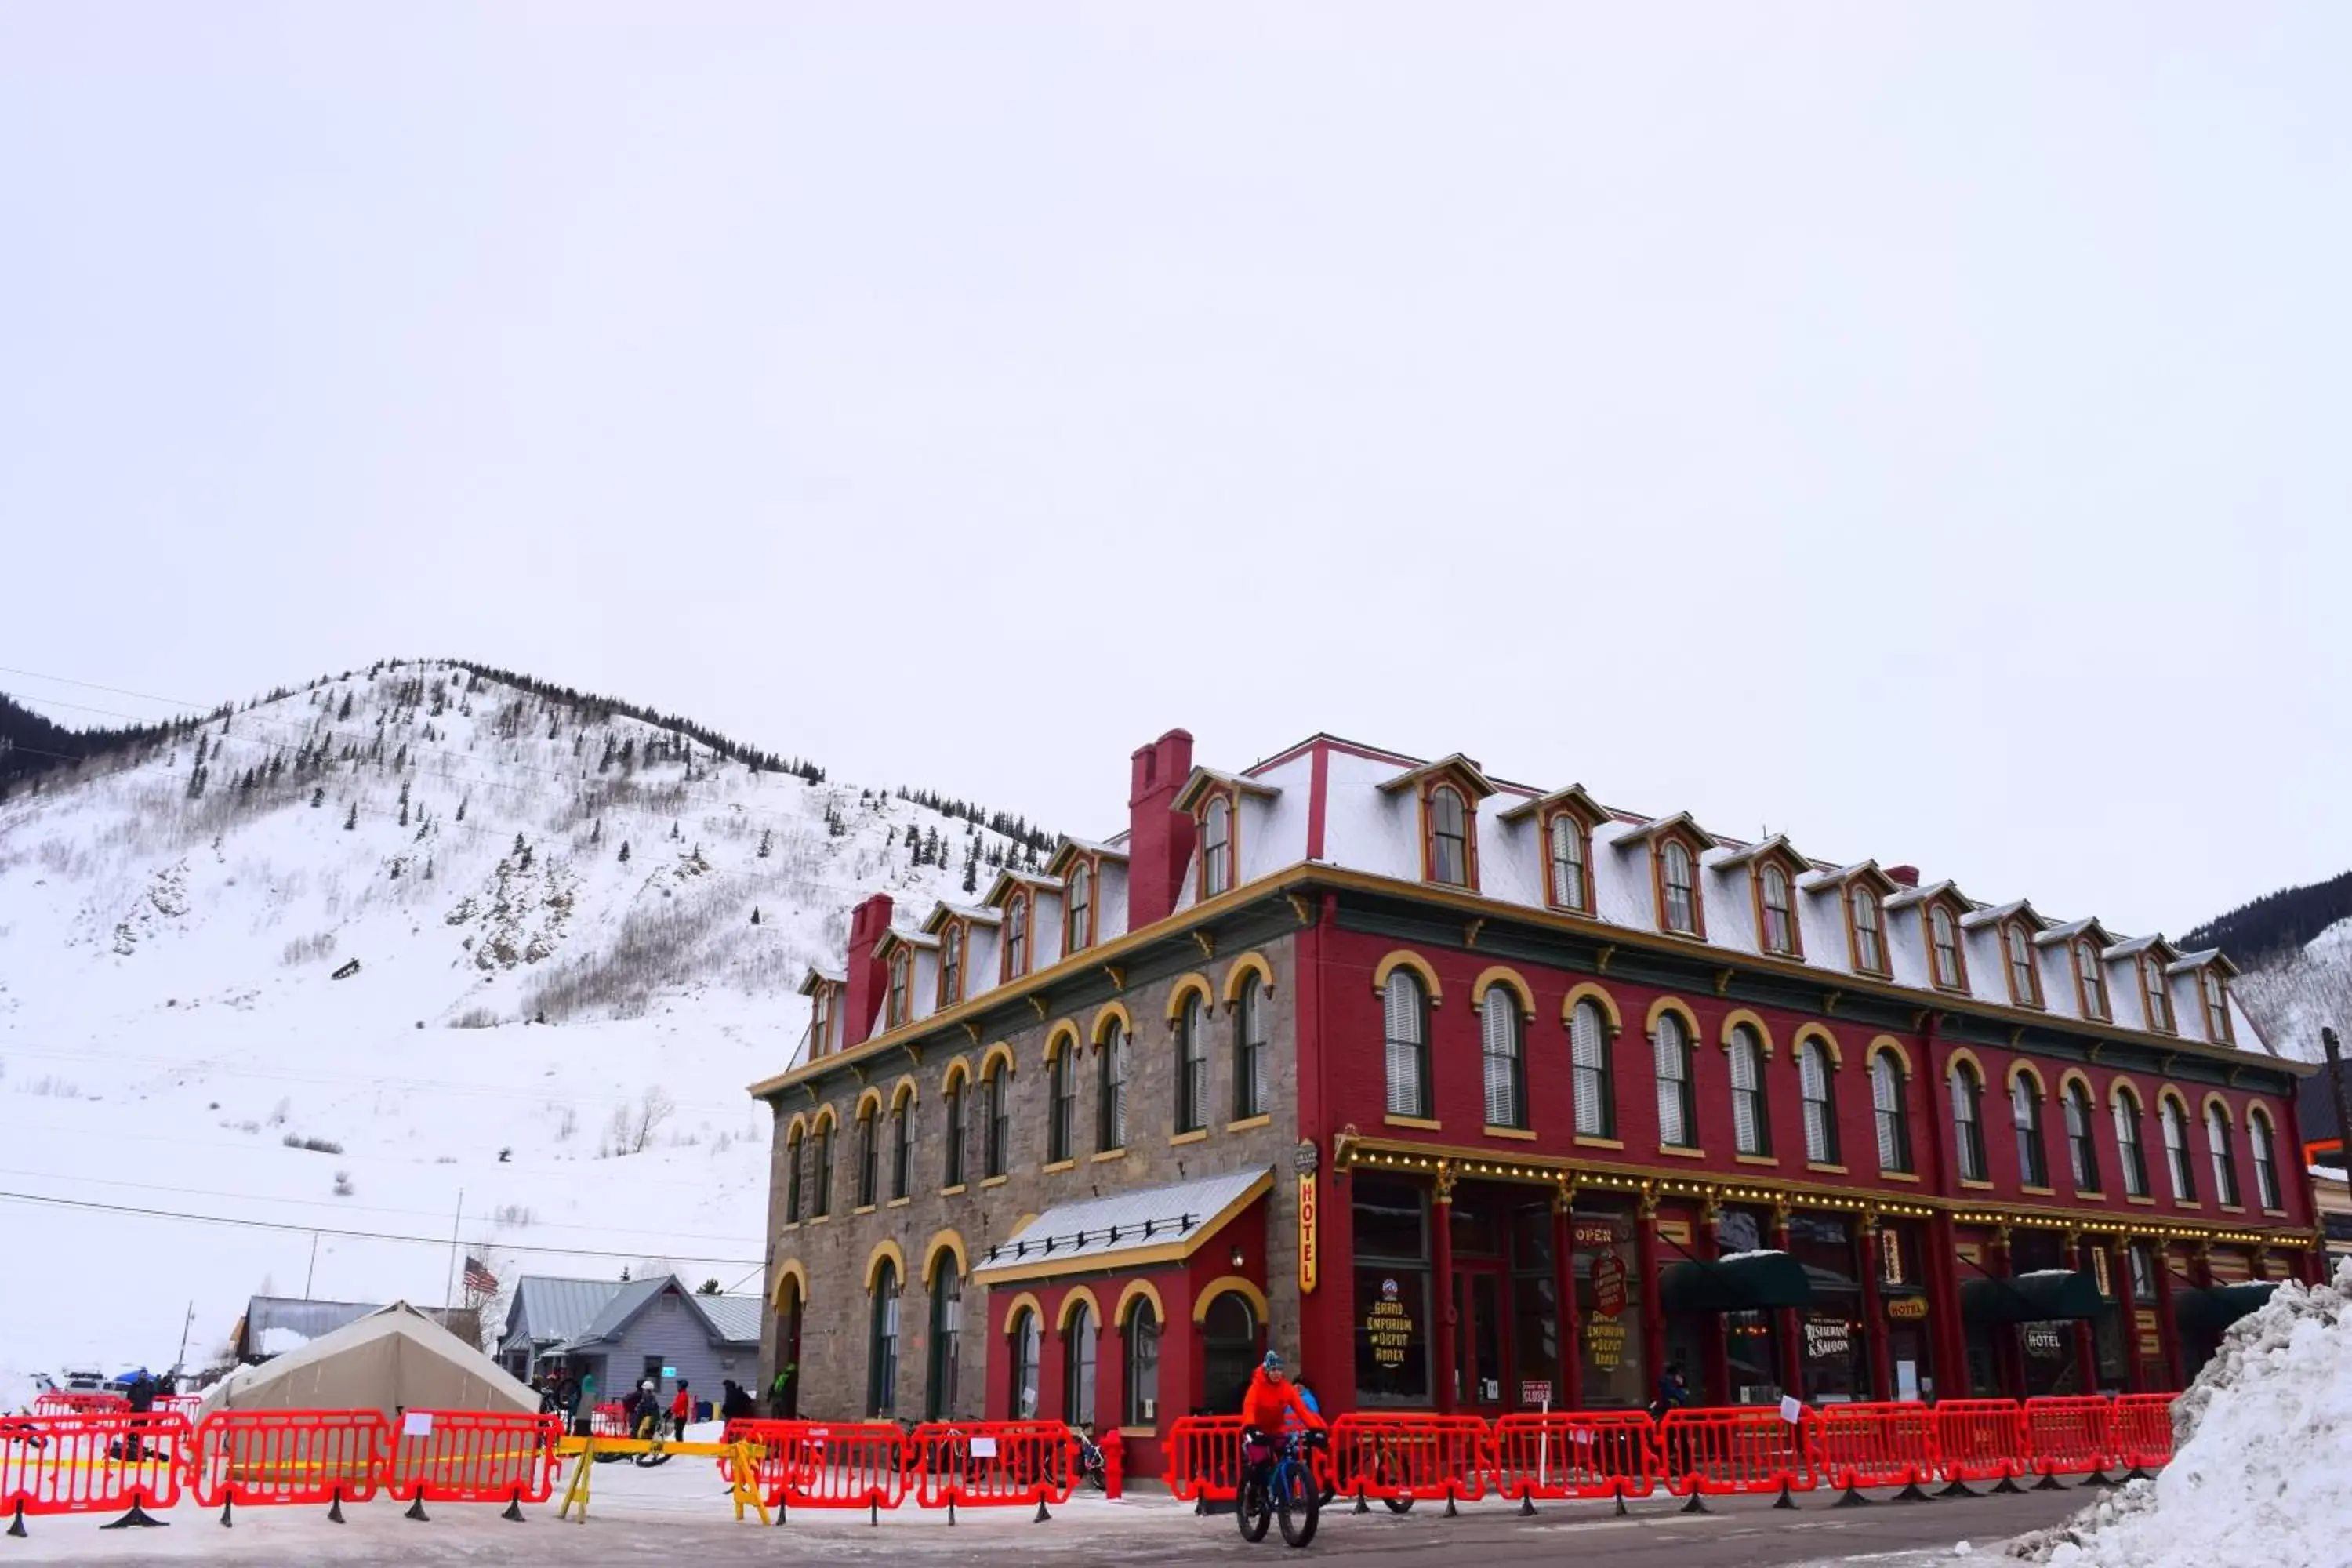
[{"xmin": 202, "ymin": 1302, "xmax": 539, "ymax": 1417}]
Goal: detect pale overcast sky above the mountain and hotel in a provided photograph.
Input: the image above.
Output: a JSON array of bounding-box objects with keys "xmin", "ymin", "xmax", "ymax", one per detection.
[{"xmin": 0, "ymin": 0, "xmax": 2352, "ymax": 933}]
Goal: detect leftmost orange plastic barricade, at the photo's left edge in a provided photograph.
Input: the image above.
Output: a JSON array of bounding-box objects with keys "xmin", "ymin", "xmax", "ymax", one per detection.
[{"xmin": 0, "ymin": 1410, "xmax": 191, "ymax": 1535}]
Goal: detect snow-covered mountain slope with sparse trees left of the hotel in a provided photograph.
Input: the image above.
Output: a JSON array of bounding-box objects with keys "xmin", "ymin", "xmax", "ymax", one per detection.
[{"xmin": 0, "ymin": 663, "xmax": 1049, "ymax": 1373}]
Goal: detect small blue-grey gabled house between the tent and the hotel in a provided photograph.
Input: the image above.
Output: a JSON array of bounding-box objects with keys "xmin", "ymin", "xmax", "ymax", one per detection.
[{"xmin": 499, "ymin": 1274, "xmax": 760, "ymax": 1403}]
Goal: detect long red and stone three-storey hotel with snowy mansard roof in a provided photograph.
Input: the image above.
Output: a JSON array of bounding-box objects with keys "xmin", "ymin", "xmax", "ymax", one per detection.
[{"xmin": 753, "ymin": 731, "xmax": 2319, "ymax": 1467}]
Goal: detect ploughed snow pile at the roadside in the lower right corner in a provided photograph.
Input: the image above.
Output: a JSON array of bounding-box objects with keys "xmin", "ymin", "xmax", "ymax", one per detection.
[{"xmin": 2027, "ymin": 1265, "xmax": 2352, "ymax": 1568}]
